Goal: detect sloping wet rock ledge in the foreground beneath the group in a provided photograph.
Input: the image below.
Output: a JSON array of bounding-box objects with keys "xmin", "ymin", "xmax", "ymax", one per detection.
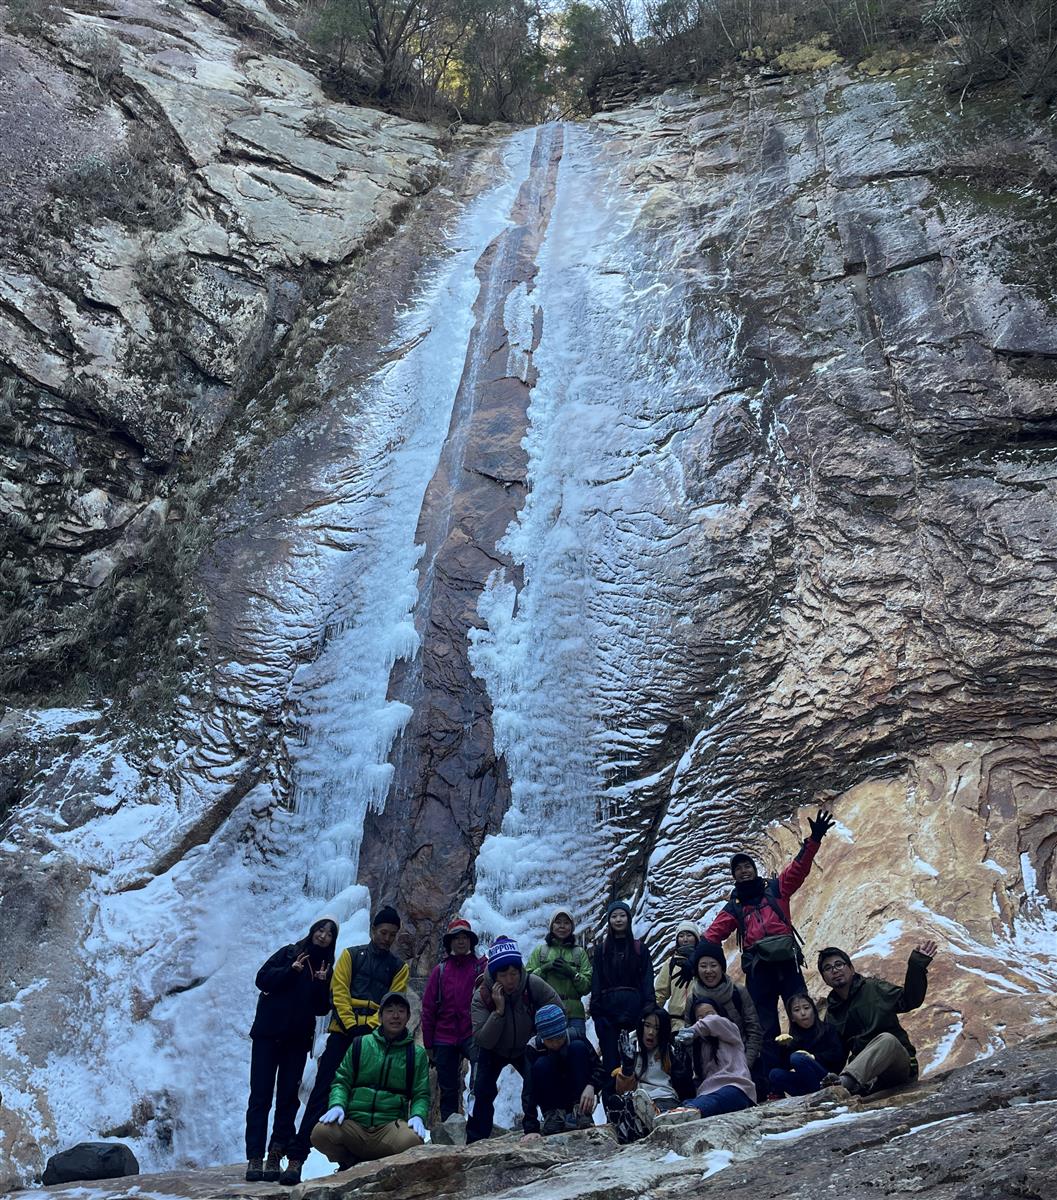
[{"xmin": 16, "ymin": 1033, "xmax": 1057, "ymax": 1200}]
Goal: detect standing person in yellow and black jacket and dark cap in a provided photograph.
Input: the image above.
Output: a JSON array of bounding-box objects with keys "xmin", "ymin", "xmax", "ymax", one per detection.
[{"xmin": 278, "ymin": 905, "xmax": 408, "ymax": 1187}]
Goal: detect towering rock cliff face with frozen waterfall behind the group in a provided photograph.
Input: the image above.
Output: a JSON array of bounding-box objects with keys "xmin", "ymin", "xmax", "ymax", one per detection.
[{"xmin": 0, "ymin": 16, "xmax": 1057, "ymax": 1195}]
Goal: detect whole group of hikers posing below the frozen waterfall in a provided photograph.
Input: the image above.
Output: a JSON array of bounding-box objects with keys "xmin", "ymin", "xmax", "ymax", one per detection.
[{"xmin": 246, "ymin": 810, "xmax": 936, "ymax": 1184}]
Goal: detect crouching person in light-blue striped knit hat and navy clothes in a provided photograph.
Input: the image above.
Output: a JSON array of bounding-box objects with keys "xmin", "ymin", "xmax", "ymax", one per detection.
[{"xmin": 526, "ymin": 1004, "xmax": 606, "ymax": 1139}]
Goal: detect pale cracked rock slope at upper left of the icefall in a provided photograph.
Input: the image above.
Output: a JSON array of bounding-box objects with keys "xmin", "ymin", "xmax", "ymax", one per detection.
[{"xmin": 0, "ymin": 0, "xmax": 440, "ymax": 679}]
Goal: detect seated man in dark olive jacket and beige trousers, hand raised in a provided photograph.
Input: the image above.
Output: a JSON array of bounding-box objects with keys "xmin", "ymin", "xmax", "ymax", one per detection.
[{"xmin": 818, "ymin": 941, "xmax": 937, "ymax": 1096}]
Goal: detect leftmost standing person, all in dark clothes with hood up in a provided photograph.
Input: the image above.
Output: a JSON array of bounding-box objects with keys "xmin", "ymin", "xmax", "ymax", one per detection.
[{"xmin": 246, "ymin": 917, "xmax": 337, "ymax": 1183}]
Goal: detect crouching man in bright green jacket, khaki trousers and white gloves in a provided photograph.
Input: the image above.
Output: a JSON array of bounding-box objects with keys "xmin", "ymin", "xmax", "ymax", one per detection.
[{"xmin": 312, "ymin": 991, "xmax": 430, "ymax": 1171}]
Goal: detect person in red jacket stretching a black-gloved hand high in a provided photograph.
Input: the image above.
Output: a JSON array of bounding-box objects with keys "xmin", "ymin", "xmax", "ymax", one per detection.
[{"xmin": 704, "ymin": 809, "xmax": 835, "ymax": 1069}]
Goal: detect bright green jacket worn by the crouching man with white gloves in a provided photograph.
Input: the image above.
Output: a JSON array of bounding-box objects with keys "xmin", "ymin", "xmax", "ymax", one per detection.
[{"xmin": 330, "ymin": 1030, "xmax": 430, "ymax": 1129}]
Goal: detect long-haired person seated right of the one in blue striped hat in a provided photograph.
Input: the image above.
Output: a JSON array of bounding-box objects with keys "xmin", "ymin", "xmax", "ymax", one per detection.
[{"xmin": 605, "ymin": 1006, "xmax": 692, "ymax": 1145}]
